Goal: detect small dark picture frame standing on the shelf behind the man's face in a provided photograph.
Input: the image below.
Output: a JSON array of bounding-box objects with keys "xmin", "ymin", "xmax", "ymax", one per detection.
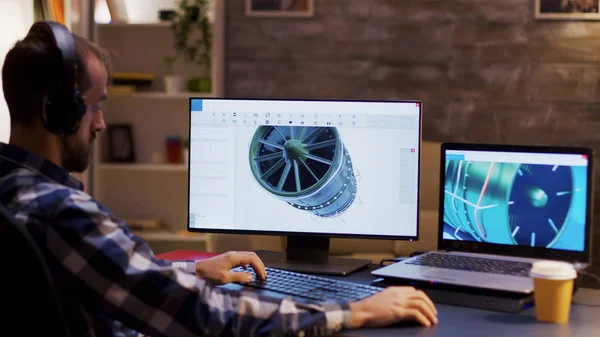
[{"xmin": 106, "ymin": 124, "xmax": 135, "ymax": 163}]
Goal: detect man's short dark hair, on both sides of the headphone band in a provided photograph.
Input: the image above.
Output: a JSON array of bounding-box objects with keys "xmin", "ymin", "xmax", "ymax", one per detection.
[{"xmin": 2, "ymin": 28, "xmax": 111, "ymax": 125}]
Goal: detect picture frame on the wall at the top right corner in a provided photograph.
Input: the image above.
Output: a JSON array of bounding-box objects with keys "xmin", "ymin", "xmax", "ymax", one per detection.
[{"xmin": 534, "ymin": 0, "xmax": 600, "ymax": 20}]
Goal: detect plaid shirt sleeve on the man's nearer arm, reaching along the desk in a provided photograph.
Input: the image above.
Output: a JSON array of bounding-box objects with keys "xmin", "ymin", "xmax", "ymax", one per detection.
[{"xmin": 47, "ymin": 193, "xmax": 350, "ymax": 337}]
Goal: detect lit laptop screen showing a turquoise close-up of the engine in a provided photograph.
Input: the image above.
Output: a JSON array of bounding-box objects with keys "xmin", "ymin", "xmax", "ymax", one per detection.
[{"xmin": 443, "ymin": 150, "xmax": 588, "ymax": 251}]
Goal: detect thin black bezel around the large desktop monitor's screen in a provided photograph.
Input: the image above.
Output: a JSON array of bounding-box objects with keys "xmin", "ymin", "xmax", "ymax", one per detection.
[{"xmin": 186, "ymin": 96, "xmax": 423, "ymax": 241}]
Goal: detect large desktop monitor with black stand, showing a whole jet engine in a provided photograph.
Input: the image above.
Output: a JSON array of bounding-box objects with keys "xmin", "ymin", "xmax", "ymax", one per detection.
[{"xmin": 188, "ymin": 97, "xmax": 422, "ymax": 275}]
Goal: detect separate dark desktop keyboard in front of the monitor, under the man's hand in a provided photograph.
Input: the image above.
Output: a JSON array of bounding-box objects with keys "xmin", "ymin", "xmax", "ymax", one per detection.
[{"xmin": 232, "ymin": 267, "xmax": 383, "ymax": 302}]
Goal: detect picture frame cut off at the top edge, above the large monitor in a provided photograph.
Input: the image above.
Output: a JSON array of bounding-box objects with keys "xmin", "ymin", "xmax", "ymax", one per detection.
[{"xmin": 246, "ymin": 0, "xmax": 315, "ymax": 18}]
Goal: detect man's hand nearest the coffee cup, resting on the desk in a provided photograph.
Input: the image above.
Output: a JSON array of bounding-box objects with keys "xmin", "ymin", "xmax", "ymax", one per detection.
[{"xmin": 350, "ymin": 287, "xmax": 438, "ymax": 329}]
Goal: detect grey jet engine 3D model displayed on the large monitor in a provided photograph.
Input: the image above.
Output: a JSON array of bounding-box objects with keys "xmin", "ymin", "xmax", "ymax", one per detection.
[{"xmin": 249, "ymin": 125, "xmax": 357, "ymax": 217}]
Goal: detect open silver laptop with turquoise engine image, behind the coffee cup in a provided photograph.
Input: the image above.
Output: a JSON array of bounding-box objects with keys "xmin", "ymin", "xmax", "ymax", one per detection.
[{"xmin": 371, "ymin": 143, "xmax": 594, "ymax": 294}]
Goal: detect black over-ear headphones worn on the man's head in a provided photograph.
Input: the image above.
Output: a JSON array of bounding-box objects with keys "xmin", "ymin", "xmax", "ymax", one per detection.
[{"xmin": 27, "ymin": 21, "xmax": 87, "ymax": 135}]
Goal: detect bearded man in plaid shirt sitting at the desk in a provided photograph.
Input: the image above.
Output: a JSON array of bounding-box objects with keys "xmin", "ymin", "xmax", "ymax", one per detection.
[{"xmin": 0, "ymin": 21, "xmax": 437, "ymax": 337}]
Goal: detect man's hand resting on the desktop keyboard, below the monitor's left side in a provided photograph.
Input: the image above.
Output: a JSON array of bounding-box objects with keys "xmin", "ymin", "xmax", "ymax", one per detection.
[{"xmin": 196, "ymin": 252, "xmax": 267, "ymax": 284}]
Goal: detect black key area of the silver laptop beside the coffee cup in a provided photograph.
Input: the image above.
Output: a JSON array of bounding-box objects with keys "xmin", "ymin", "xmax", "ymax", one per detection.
[{"xmin": 404, "ymin": 253, "xmax": 531, "ymax": 276}]
